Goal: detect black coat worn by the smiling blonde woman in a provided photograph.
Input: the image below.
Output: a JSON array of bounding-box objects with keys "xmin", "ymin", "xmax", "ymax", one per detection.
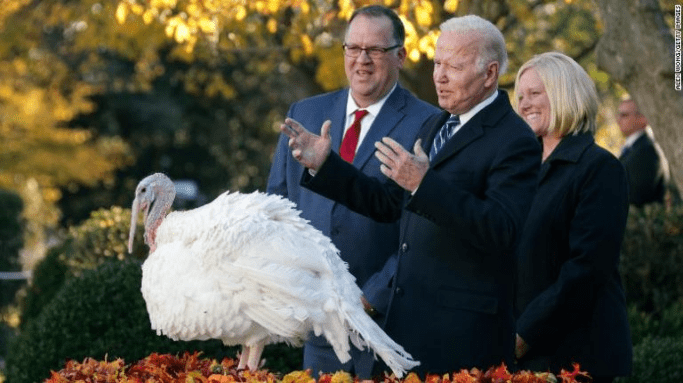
[{"xmin": 516, "ymin": 134, "xmax": 632, "ymax": 377}]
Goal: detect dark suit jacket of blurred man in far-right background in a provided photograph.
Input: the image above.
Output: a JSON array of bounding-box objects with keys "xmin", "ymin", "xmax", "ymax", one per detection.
[{"xmin": 619, "ymin": 132, "xmax": 669, "ymax": 206}]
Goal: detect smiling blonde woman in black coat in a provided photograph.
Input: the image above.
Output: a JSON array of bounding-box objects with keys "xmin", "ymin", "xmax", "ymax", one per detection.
[{"xmin": 515, "ymin": 52, "xmax": 632, "ymax": 383}]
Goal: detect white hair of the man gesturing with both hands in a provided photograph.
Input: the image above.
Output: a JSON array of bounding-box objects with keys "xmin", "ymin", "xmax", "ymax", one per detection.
[{"xmin": 439, "ymin": 15, "xmax": 508, "ymax": 76}]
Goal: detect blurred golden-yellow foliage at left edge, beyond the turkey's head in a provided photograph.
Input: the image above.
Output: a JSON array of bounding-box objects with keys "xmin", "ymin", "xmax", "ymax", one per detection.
[{"xmin": 0, "ymin": 54, "xmax": 132, "ymax": 234}]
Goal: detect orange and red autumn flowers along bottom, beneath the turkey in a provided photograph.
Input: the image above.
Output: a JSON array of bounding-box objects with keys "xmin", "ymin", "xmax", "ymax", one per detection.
[{"xmin": 45, "ymin": 352, "xmax": 590, "ymax": 383}]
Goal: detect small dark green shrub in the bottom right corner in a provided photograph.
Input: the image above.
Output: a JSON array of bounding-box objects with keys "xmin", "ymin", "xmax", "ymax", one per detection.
[{"xmin": 616, "ymin": 337, "xmax": 683, "ymax": 383}]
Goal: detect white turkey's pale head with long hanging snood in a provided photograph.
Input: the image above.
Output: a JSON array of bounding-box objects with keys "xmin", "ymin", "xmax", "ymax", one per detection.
[{"xmin": 128, "ymin": 173, "xmax": 175, "ymax": 253}]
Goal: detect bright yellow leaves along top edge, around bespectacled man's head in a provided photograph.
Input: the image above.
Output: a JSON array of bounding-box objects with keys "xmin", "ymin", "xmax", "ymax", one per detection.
[{"xmin": 116, "ymin": 0, "xmax": 458, "ymax": 71}]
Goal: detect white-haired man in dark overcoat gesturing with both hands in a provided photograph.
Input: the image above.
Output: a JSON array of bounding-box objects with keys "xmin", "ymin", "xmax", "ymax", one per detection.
[{"xmin": 280, "ymin": 16, "xmax": 541, "ymax": 374}]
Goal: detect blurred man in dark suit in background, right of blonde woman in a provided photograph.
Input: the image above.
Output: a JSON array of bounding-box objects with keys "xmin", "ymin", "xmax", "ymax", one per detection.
[{"xmin": 617, "ymin": 100, "xmax": 670, "ymax": 207}]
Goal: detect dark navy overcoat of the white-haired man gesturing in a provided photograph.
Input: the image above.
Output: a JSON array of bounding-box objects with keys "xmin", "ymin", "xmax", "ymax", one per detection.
[{"xmin": 302, "ymin": 91, "xmax": 541, "ymax": 374}]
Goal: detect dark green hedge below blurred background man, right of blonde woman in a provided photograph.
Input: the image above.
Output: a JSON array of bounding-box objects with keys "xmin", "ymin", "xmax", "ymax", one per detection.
[{"xmin": 621, "ymin": 205, "xmax": 683, "ymax": 314}]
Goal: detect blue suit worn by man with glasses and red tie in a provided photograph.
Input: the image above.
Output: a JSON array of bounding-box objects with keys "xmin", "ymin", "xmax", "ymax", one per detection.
[{"xmin": 267, "ymin": 85, "xmax": 439, "ymax": 376}]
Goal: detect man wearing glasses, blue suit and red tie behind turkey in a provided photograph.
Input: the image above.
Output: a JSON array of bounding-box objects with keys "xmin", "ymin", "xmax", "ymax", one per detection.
[{"xmin": 267, "ymin": 6, "xmax": 439, "ymax": 378}]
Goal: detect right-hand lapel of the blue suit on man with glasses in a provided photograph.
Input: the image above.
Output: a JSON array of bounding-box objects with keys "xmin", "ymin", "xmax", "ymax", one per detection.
[{"xmin": 353, "ymin": 85, "xmax": 412, "ymax": 169}]
